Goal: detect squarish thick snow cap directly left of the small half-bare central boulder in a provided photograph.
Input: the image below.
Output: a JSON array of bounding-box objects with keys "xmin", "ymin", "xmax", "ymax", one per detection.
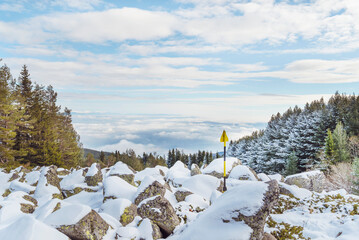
[{"xmin": 103, "ymin": 176, "xmax": 137, "ymax": 201}]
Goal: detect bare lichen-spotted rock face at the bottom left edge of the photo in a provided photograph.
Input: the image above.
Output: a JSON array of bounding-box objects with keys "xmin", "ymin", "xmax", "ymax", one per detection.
[{"xmin": 57, "ymin": 210, "xmax": 110, "ymax": 240}]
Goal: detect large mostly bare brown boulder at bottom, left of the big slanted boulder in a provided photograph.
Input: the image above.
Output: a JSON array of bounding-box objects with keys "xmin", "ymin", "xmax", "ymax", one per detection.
[{"xmin": 137, "ymin": 196, "xmax": 180, "ymax": 237}]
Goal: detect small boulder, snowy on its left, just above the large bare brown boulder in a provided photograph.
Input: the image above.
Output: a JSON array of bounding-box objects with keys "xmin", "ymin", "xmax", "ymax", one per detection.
[{"xmin": 135, "ymin": 176, "xmax": 166, "ymax": 205}]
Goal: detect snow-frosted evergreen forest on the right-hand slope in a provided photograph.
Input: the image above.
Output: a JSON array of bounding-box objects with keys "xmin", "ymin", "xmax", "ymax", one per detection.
[{"xmin": 229, "ymin": 92, "xmax": 359, "ymax": 174}]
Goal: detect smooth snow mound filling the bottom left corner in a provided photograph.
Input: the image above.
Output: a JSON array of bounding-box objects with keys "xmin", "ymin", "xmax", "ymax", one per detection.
[{"xmin": 0, "ymin": 215, "xmax": 69, "ymax": 240}]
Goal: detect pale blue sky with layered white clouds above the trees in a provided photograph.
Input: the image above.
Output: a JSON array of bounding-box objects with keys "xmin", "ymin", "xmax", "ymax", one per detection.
[{"xmin": 0, "ymin": 0, "xmax": 359, "ymax": 154}]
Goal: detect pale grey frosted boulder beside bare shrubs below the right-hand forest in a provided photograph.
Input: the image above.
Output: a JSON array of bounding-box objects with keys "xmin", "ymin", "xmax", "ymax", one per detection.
[{"xmin": 284, "ymin": 170, "xmax": 327, "ymax": 192}]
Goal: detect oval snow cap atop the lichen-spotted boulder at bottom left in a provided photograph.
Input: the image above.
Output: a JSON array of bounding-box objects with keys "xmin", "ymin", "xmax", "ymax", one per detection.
[{"xmin": 44, "ymin": 204, "xmax": 91, "ymax": 227}]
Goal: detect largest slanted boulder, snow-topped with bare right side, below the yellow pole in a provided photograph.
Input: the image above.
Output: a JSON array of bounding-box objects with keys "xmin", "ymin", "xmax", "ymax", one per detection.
[{"xmin": 178, "ymin": 180, "xmax": 279, "ymax": 240}]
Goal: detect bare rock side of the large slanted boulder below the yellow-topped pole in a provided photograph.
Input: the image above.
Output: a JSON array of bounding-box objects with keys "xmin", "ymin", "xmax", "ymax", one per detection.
[{"xmin": 232, "ymin": 180, "xmax": 279, "ymax": 240}]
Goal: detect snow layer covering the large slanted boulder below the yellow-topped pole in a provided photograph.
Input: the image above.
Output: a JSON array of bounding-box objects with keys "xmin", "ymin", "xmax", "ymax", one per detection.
[{"xmin": 174, "ymin": 181, "xmax": 268, "ymax": 240}]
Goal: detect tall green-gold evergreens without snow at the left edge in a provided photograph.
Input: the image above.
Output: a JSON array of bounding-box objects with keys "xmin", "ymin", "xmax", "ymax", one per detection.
[{"xmin": 0, "ymin": 62, "xmax": 83, "ymax": 168}]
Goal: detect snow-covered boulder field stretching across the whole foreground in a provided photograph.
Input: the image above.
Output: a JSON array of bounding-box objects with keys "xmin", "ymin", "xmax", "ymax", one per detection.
[{"xmin": 0, "ymin": 158, "xmax": 359, "ymax": 240}]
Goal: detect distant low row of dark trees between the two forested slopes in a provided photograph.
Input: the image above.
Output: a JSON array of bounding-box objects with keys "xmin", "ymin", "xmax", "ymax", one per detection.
[{"xmin": 83, "ymin": 149, "xmax": 219, "ymax": 171}]
